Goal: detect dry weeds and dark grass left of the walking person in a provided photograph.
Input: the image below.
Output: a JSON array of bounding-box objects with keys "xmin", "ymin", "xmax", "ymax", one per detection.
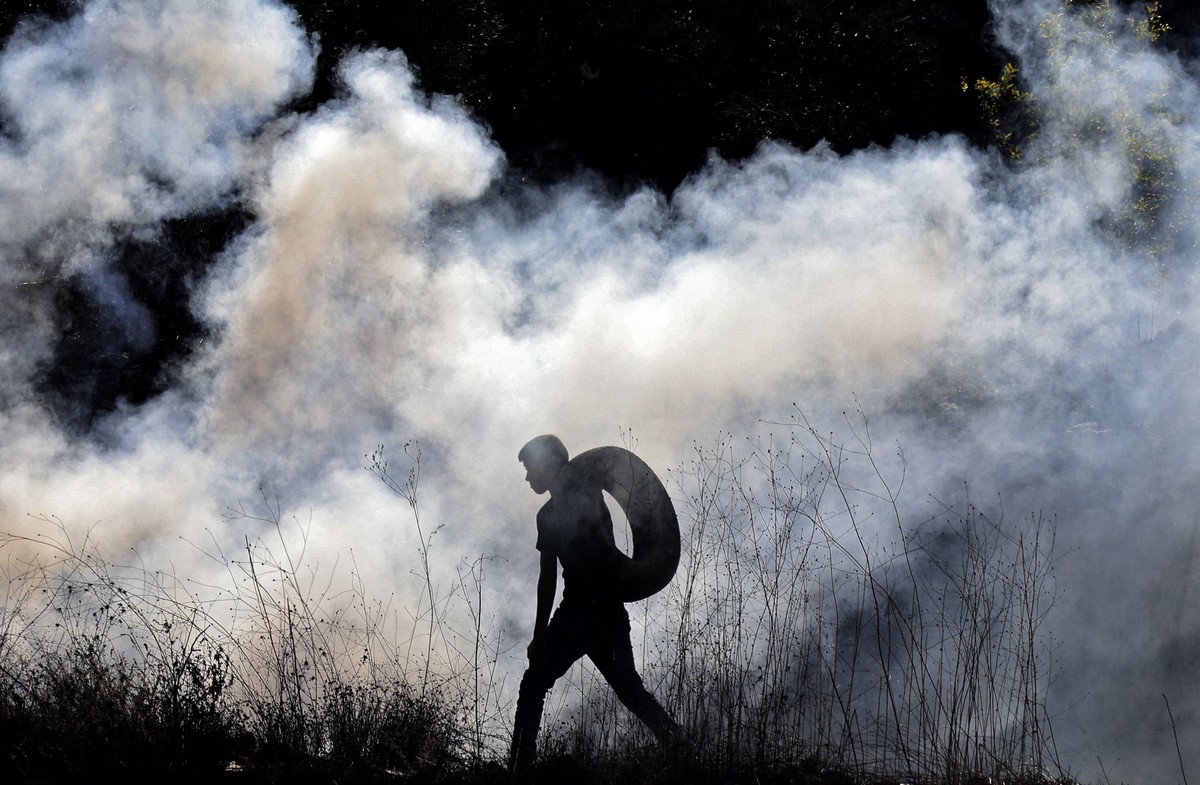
[{"xmin": 0, "ymin": 441, "xmax": 508, "ymax": 781}]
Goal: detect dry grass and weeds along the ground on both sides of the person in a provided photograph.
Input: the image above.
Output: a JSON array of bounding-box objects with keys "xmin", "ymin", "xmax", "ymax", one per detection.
[{"xmin": 0, "ymin": 429, "xmax": 1064, "ymax": 785}]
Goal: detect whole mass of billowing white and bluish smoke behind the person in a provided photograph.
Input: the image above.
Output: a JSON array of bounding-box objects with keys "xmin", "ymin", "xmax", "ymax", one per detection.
[{"xmin": 0, "ymin": 0, "xmax": 1200, "ymax": 777}]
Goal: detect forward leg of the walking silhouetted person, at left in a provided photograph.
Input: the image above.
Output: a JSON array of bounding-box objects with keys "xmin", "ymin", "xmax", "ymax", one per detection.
[{"xmin": 509, "ymin": 606, "xmax": 587, "ymax": 769}]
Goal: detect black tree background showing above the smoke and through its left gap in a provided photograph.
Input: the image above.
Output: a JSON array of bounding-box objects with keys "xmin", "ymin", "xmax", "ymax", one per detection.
[{"xmin": 0, "ymin": 0, "xmax": 1200, "ymax": 427}]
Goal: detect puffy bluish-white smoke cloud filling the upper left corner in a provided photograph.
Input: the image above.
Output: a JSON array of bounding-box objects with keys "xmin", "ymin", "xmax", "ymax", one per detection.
[{"xmin": 0, "ymin": 0, "xmax": 314, "ymax": 394}]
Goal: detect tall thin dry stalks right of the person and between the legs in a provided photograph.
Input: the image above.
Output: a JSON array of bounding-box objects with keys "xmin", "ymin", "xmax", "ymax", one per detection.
[{"xmin": 557, "ymin": 413, "xmax": 1058, "ymax": 781}]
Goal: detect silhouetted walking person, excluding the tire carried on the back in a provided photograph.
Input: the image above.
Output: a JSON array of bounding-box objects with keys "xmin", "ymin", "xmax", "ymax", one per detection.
[{"xmin": 509, "ymin": 435, "xmax": 679, "ymax": 768}]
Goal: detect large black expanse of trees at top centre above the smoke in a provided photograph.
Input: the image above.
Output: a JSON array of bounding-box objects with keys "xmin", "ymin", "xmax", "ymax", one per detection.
[{"xmin": 293, "ymin": 0, "xmax": 1002, "ymax": 191}]
